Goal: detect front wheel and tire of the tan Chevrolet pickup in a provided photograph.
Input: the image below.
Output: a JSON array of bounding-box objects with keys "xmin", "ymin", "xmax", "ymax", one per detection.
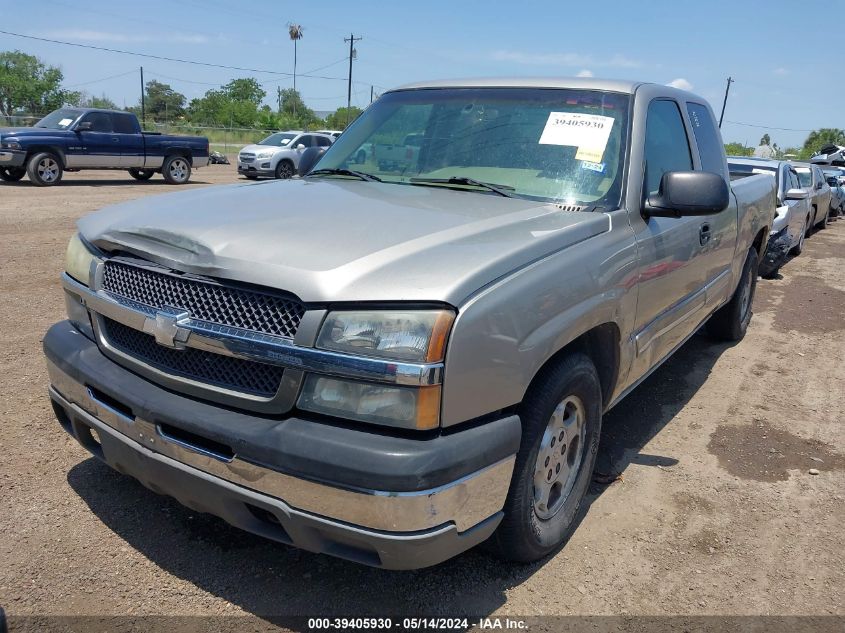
[{"xmin": 489, "ymin": 353, "xmax": 602, "ymax": 562}]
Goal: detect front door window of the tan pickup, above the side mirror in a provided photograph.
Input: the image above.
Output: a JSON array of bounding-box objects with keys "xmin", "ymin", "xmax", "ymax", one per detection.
[{"xmin": 645, "ymin": 99, "xmax": 692, "ymax": 193}]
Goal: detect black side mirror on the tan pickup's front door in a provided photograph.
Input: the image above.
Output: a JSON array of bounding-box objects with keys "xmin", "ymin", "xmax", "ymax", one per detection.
[{"xmin": 643, "ymin": 171, "xmax": 730, "ymax": 218}]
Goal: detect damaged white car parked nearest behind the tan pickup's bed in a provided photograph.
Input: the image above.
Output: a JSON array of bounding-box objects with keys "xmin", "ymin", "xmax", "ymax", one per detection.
[{"xmin": 728, "ymin": 156, "xmax": 814, "ymax": 277}]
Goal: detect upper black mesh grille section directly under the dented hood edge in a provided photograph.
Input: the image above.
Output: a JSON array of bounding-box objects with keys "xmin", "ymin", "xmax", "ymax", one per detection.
[{"xmin": 103, "ymin": 260, "xmax": 305, "ymax": 338}]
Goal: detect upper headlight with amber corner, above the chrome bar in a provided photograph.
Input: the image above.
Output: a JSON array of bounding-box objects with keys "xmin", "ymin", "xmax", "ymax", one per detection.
[{"xmin": 317, "ymin": 310, "xmax": 455, "ymax": 363}]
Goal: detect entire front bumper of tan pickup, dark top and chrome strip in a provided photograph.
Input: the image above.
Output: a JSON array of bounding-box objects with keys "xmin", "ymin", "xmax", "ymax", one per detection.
[{"xmin": 44, "ymin": 322, "xmax": 519, "ymax": 569}]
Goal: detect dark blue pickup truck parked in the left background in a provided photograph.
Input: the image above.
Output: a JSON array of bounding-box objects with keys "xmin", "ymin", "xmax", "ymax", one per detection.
[{"xmin": 0, "ymin": 108, "xmax": 209, "ymax": 187}]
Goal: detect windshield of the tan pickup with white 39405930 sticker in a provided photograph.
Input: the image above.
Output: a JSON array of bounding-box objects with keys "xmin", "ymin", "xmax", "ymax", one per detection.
[{"xmin": 318, "ymin": 88, "xmax": 630, "ymax": 206}]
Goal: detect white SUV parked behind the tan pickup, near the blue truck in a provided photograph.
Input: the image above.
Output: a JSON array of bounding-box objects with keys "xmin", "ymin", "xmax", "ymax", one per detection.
[{"xmin": 238, "ymin": 130, "xmax": 334, "ymax": 180}]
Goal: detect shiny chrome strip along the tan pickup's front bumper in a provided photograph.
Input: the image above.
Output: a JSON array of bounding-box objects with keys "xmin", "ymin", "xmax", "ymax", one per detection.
[{"xmin": 47, "ymin": 360, "xmax": 516, "ymax": 532}]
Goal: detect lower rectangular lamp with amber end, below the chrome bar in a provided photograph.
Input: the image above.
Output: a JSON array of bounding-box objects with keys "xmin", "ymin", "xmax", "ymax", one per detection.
[{"xmin": 297, "ymin": 374, "xmax": 440, "ymax": 430}]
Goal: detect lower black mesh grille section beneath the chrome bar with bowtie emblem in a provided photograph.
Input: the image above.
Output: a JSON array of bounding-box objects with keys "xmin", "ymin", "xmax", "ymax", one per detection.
[{"xmin": 103, "ymin": 317, "xmax": 284, "ymax": 398}]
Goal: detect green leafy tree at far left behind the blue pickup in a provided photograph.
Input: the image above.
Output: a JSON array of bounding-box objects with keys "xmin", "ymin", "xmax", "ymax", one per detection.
[{"xmin": 0, "ymin": 51, "xmax": 80, "ymax": 118}]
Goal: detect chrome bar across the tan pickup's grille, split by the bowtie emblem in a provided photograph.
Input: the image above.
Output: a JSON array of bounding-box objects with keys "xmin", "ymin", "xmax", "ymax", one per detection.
[{"xmin": 62, "ymin": 273, "xmax": 443, "ymax": 387}]
